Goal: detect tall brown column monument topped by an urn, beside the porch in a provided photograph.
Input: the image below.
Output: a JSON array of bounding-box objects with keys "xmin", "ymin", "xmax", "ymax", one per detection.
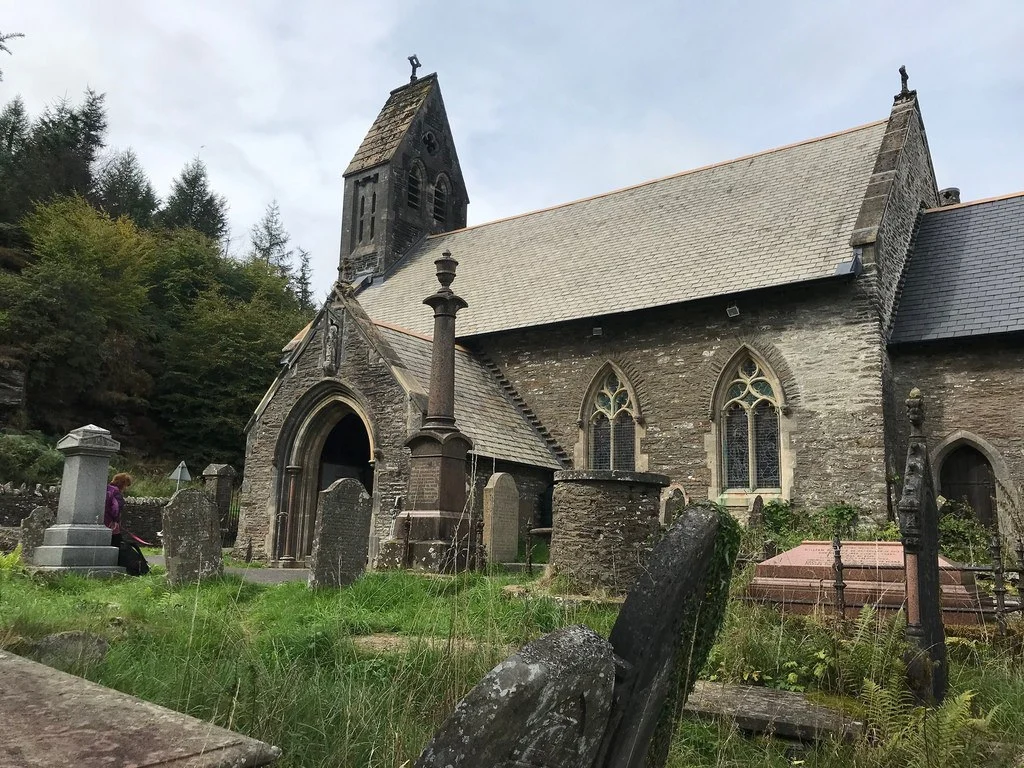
[{"xmin": 378, "ymin": 251, "xmax": 473, "ymax": 570}]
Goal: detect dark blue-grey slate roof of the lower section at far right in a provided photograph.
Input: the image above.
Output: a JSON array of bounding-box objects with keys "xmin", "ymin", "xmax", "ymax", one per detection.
[{"xmin": 890, "ymin": 193, "xmax": 1024, "ymax": 344}]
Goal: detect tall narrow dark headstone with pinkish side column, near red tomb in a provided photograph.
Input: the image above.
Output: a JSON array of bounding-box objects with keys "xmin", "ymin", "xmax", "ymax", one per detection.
[{"xmin": 897, "ymin": 387, "xmax": 947, "ymax": 701}]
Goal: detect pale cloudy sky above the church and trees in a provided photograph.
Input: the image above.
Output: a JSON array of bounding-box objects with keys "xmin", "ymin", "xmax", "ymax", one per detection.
[{"xmin": 0, "ymin": 0, "xmax": 1024, "ymax": 297}]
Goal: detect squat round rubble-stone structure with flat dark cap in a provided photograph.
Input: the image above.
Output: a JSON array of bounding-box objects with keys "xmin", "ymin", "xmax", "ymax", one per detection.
[{"xmin": 548, "ymin": 470, "xmax": 670, "ymax": 593}]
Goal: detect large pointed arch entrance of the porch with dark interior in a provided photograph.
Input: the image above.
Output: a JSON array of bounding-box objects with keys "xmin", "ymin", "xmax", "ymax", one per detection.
[{"xmin": 274, "ymin": 394, "xmax": 374, "ymax": 567}]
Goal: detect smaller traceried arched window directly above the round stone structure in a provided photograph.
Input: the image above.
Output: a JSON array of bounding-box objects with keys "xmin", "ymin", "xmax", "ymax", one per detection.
[{"xmin": 588, "ymin": 370, "xmax": 637, "ymax": 472}]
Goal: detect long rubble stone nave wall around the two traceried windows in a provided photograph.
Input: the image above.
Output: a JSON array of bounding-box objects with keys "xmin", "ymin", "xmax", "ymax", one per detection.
[{"xmin": 474, "ymin": 280, "xmax": 886, "ymax": 516}]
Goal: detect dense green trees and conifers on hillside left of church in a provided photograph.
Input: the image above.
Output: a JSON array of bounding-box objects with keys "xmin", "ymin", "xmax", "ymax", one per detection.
[{"xmin": 0, "ymin": 91, "xmax": 312, "ymax": 466}]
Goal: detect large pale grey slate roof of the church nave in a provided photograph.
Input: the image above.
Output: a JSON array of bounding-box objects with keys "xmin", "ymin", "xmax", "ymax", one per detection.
[{"xmin": 358, "ymin": 121, "xmax": 886, "ymax": 336}]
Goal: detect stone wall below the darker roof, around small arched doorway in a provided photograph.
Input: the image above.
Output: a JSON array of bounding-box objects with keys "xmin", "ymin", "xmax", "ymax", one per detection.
[{"xmin": 892, "ymin": 338, "xmax": 1024, "ymax": 536}]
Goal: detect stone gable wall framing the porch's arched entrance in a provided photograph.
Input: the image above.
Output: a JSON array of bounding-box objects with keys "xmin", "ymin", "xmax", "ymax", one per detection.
[{"xmin": 237, "ymin": 317, "xmax": 410, "ymax": 559}]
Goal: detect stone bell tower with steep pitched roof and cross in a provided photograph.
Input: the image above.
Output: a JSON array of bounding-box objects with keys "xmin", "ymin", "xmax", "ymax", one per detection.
[{"xmin": 339, "ymin": 55, "xmax": 469, "ymax": 275}]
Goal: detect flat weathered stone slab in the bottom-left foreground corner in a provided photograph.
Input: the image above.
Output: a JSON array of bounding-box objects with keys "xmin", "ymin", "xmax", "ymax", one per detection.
[{"xmin": 0, "ymin": 651, "xmax": 281, "ymax": 768}]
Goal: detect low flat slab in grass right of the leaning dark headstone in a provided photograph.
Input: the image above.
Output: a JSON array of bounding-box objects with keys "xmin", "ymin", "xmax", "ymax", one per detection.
[{"xmin": 685, "ymin": 680, "xmax": 864, "ymax": 741}]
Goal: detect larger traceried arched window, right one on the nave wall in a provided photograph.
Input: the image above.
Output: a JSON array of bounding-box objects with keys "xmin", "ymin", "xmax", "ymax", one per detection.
[{"xmin": 721, "ymin": 355, "xmax": 781, "ymax": 490}]
